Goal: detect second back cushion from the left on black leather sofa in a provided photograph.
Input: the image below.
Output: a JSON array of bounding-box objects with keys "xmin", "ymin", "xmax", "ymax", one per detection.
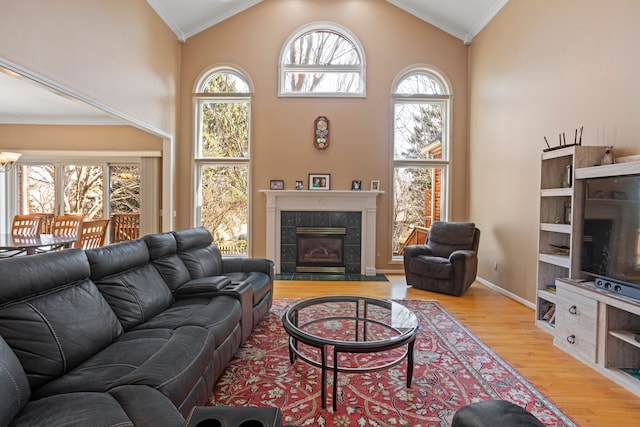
[{"xmin": 86, "ymin": 240, "xmax": 173, "ymax": 330}]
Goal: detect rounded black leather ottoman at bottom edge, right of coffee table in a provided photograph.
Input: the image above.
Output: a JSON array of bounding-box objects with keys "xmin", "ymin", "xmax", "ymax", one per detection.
[{"xmin": 451, "ymin": 400, "xmax": 545, "ymax": 427}]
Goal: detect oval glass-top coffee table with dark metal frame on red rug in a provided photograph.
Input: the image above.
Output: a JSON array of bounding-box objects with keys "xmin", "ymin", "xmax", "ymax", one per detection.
[{"xmin": 282, "ymin": 295, "xmax": 418, "ymax": 409}]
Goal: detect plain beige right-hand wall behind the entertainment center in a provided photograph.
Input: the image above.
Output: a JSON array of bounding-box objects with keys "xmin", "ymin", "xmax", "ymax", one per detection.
[{"xmin": 469, "ymin": 0, "xmax": 640, "ymax": 301}]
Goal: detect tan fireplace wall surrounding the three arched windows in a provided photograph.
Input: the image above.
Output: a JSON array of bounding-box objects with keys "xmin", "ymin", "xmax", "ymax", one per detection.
[{"xmin": 177, "ymin": 0, "xmax": 468, "ymax": 270}]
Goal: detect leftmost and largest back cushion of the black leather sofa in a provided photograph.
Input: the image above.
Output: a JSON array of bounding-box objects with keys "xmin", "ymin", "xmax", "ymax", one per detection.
[{"xmin": 0, "ymin": 249, "xmax": 122, "ymax": 392}]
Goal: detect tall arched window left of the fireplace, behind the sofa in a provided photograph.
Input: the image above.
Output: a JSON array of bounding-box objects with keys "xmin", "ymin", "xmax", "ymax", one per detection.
[{"xmin": 195, "ymin": 68, "xmax": 251, "ymax": 255}]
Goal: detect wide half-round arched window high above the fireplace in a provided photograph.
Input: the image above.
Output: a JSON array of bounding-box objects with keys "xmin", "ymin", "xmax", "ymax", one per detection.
[{"xmin": 278, "ymin": 22, "xmax": 366, "ymax": 97}]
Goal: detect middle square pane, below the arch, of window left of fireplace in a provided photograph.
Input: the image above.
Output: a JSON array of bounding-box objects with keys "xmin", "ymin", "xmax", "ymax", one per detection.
[{"xmin": 199, "ymin": 100, "xmax": 249, "ymax": 158}]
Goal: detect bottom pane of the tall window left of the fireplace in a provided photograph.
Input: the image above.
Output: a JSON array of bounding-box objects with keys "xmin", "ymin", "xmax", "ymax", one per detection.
[{"xmin": 200, "ymin": 165, "xmax": 249, "ymax": 255}]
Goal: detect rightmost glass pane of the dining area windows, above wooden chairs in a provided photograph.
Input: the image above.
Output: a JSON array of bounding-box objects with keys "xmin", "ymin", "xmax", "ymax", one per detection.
[{"xmin": 109, "ymin": 165, "xmax": 140, "ymax": 214}]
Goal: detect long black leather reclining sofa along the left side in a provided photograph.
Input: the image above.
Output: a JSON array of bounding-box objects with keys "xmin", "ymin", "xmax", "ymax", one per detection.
[{"xmin": 0, "ymin": 227, "xmax": 274, "ymax": 427}]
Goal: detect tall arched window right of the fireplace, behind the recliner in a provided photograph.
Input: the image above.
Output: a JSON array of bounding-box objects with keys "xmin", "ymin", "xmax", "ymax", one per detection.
[{"xmin": 392, "ymin": 69, "xmax": 450, "ymax": 257}]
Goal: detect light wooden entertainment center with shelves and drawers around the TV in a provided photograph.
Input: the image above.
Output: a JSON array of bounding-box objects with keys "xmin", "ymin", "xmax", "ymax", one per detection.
[{"xmin": 536, "ymin": 145, "xmax": 640, "ymax": 396}]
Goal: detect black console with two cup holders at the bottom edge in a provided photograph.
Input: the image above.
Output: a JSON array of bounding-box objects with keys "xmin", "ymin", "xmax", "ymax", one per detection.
[{"xmin": 184, "ymin": 406, "xmax": 282, "ymax": 427}]
